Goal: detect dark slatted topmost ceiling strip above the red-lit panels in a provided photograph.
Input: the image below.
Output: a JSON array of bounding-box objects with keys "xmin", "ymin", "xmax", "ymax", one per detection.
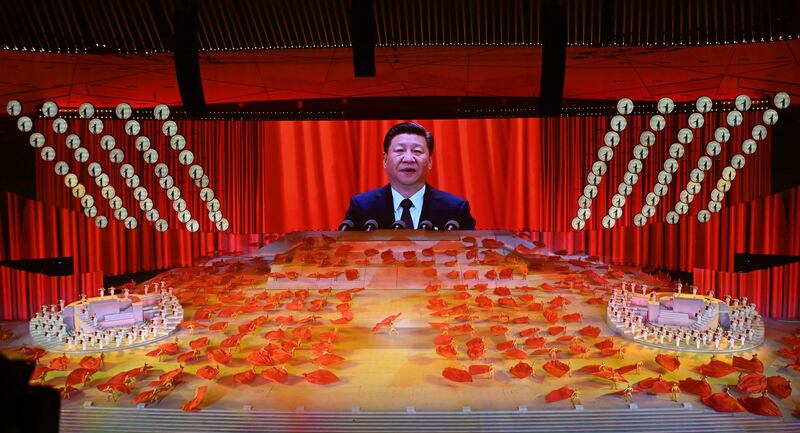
[{"xmin": 0, "ymin": 0, "xmax": 800, "ymax": 54}]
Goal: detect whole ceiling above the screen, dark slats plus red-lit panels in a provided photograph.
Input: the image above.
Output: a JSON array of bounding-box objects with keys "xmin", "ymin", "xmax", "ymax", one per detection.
[{"xmin": 0, "ymin": 0, "xmax": 800, "ymax": 118}]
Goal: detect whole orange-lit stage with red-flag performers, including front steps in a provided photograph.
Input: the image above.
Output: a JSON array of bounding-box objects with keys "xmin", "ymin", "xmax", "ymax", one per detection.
[{"xmin": 2, "ymin": 231, "xmax": 800, "ymax": 432}]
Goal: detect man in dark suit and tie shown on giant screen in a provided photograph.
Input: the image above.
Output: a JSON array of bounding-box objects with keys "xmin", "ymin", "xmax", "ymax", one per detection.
[{"xmin": 345, "ymin": 122, "xmax": 475, "ymax": 230}]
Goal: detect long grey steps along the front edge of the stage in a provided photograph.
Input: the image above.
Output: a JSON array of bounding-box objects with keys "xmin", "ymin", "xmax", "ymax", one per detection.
[{"xmin": 60, "ymin": 407, "xmax": 800, "ymax": 433}]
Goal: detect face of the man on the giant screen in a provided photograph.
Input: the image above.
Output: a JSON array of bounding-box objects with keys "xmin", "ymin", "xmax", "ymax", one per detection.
[{"xmin": 383, "ymin": 134, "xmax": 433, "ymax": 186}]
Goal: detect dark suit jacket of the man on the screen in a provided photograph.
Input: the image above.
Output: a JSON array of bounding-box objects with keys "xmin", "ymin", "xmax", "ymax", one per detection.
[{"xmin": 344, "ymin": 184, "xmax": 475, "ymax": 230}]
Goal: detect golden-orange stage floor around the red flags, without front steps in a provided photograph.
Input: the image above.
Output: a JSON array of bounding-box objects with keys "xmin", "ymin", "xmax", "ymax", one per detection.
[{"xmin": 0, "ymin": 232, "xmax": 800, "ymax": 431}]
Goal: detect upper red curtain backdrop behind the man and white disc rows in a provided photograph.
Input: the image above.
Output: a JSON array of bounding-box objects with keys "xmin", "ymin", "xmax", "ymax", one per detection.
[{"xmin": 36, "ymin": 112, "xmax": 771, "ymax": 233}]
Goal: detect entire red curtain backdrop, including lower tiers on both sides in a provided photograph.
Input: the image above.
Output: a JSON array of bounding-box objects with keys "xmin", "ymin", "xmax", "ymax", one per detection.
[{"xmin": 0, "ymin": 112, "xmax": 800, "ymax": 318}]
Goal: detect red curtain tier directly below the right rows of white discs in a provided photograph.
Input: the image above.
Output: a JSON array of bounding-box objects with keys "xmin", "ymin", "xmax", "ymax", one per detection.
[{"xmin": 531, "ymin": 186, "xmax": 800, "ymax": 272}]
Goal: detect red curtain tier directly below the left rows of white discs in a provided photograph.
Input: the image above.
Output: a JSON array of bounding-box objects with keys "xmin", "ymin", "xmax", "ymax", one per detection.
[{"xmin": 0, "ymin": 191, "xmax": 278, "ymax": 276}]
